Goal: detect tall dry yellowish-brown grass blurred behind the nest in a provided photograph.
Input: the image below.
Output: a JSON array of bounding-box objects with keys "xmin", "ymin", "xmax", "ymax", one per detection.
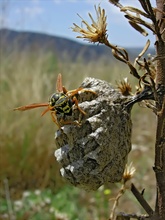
[{"xmin": 0, "ymin": 47, "xmax": 156, "ymax": 217}]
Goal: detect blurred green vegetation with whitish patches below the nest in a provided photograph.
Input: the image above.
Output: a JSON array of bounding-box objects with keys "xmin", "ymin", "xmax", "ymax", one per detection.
[{"xmin": 0, "ymin": 186, "xmax": 111, "ymax": 220}]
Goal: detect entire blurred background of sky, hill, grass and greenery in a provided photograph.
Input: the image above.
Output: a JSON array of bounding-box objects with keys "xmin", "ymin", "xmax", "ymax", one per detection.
[{"xmin": 0, "ymin": 0, "xmax": 156, "ymax": 220}]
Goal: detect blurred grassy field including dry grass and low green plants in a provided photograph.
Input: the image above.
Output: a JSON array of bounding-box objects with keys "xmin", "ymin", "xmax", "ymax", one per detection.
[{"xmin": 0, "ymin": 49, "xmax": 156, "ymax": 220}]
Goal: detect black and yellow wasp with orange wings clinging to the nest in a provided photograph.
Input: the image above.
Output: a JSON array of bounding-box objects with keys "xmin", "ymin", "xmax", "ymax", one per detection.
[{"xmin": 14, "ymin": 73, "xmax": 96, "ymax": 129}]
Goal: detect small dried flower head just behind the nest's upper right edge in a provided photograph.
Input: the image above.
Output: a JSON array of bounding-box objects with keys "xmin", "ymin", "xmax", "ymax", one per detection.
[{"xmin": 117, "ymin": 78, "xmax": 132, "ymax": 96}]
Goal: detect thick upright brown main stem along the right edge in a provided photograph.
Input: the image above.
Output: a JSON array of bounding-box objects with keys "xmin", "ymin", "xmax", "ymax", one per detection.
[{"xmin": 154, "ymin": 0, "xmax": 165, "ymax": 220}]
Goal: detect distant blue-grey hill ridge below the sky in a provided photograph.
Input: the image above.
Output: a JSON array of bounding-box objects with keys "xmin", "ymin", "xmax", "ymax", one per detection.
[{"xmin": 0, "ymin": 29, "xmax": 155, "ymax": 61}]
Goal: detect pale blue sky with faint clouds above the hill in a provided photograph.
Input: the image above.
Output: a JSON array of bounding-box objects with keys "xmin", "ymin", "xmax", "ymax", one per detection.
[{"xmin": 0, "ymin": 0, "xmax": 155, "ymax": 47}]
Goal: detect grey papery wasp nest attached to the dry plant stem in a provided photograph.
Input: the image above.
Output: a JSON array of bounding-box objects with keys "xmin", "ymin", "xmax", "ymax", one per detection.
[{"xmin": 55, "ymin": 78, "xmax": 132, "ymax": 190}]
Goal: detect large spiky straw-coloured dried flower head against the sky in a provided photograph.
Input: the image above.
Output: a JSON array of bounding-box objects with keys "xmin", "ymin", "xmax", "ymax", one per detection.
[{"xmin": 71, "ymin": 6, "xmax": 107, "ymax": 43}]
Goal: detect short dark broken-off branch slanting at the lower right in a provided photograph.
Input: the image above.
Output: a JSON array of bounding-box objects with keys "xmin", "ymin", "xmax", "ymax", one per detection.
[{"xmin": 131, "ymin": 183, "xmax": 154, "ymax": 216}]
